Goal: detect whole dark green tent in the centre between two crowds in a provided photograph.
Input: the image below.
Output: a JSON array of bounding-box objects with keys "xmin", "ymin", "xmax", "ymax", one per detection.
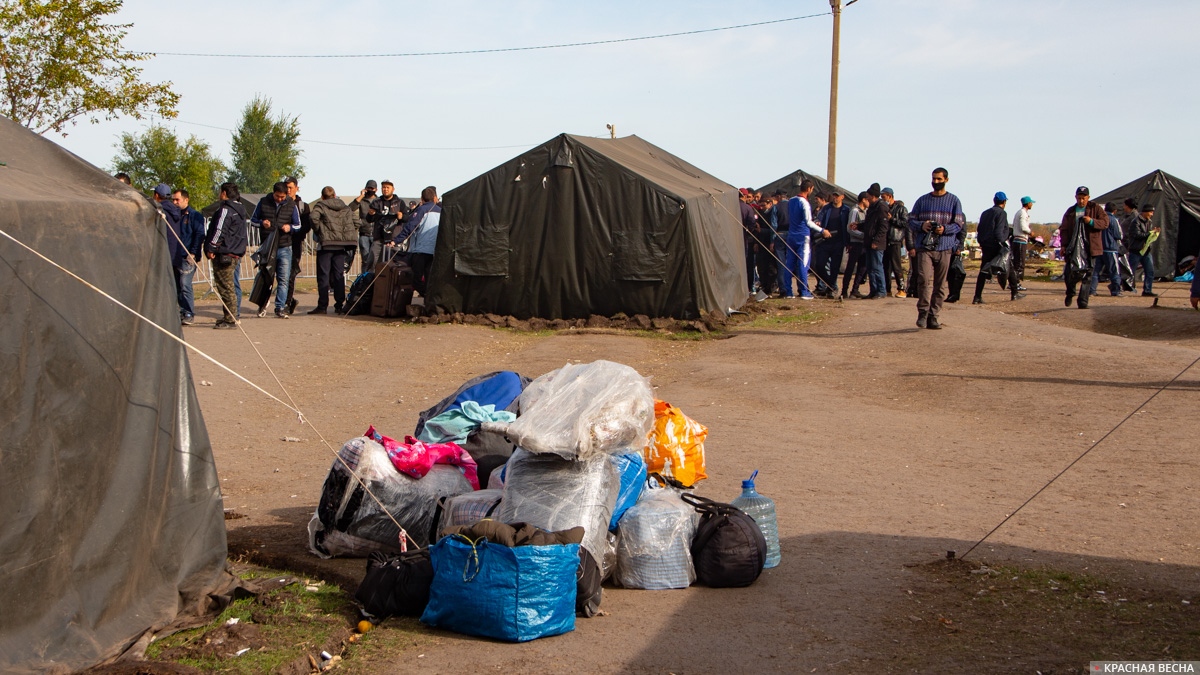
[{"xmin": 428, "ymin": 133, "xmax": 746, "ymax": 318}]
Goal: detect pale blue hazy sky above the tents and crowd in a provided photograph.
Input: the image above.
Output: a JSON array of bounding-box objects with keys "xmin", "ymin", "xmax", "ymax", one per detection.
[{"xmin": 48, "ymin": 0, "xmax": 1200, "ymax": 221}]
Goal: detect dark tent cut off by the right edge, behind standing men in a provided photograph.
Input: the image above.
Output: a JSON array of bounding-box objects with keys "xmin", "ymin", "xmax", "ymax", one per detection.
[{"xmin": 1092, "ymin": 171, "xmax": 1200, "ymax": 276}]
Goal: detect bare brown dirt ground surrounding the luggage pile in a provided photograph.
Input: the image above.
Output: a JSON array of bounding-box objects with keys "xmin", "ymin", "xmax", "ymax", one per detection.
[{"xmin": 185, "ymin": 280, "xmax": 1200, "ymax": 673}]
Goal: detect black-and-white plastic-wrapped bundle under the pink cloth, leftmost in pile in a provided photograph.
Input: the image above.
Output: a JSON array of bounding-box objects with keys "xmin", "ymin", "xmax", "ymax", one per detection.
[{"xmin": 308, "ymin": 436, "xmax": 472, "ymax": 557}]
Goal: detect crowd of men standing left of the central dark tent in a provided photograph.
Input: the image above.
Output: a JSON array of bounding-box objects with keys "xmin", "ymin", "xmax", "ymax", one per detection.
[{"xmin": 115, "ymin": 174, "xmax": 442, "ymax": 329}]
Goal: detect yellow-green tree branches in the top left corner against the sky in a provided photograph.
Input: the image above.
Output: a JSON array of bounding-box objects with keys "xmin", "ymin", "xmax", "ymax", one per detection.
[{"xmin": 0, "ymin": 0, "xmax": 179, "ymax": 136}]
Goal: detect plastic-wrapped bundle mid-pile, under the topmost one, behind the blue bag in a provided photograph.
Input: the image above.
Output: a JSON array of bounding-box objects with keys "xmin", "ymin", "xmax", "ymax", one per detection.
[{"xmin": 494, "ymin": 448, "xmax": 620, "ymax": 566}]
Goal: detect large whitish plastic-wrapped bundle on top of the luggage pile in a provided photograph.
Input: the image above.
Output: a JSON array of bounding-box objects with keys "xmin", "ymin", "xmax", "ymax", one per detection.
[{"xmin": 484, "ymin": 360, "xmax": 654, "ymax": 460}]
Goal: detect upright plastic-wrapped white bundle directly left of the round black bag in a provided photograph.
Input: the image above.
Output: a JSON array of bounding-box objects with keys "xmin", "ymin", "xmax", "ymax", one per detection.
[{"xmin": 613, "ymin": 488, "xmax": 698, "ymax": 591}]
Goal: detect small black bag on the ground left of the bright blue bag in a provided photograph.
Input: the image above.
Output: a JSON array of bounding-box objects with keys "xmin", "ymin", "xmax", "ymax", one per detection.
[{"xmin": 354, "ymin": 549, "xmax": 433, "ymax": 619}]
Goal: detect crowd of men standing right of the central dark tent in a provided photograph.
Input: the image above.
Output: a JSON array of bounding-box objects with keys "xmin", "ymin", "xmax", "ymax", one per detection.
[{"xmin": 740, "ymin": 167, "xmax": 1200, "ymax": 329}]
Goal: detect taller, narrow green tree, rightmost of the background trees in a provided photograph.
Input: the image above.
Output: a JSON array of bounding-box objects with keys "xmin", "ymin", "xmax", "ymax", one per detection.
[{"xmin": 230, "ymin": 96, "xmax": 304, "ymax": 192}]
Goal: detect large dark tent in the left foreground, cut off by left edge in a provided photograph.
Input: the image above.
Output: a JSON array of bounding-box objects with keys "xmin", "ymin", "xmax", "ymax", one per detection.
[{"xmin": 0, "ymin": 118, "xmax": 236, "ymax": 673}]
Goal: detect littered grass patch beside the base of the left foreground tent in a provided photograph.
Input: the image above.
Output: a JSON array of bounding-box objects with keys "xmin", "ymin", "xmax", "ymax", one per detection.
[{"xmin": 146, "ymin": 568, "xmax": 356, "ymax": 675}]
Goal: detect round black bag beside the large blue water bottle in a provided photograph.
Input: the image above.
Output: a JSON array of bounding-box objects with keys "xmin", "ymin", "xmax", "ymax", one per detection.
[{"xmin": 682, "ymin": 492, "xmax": 767, "ymax": 589}]
